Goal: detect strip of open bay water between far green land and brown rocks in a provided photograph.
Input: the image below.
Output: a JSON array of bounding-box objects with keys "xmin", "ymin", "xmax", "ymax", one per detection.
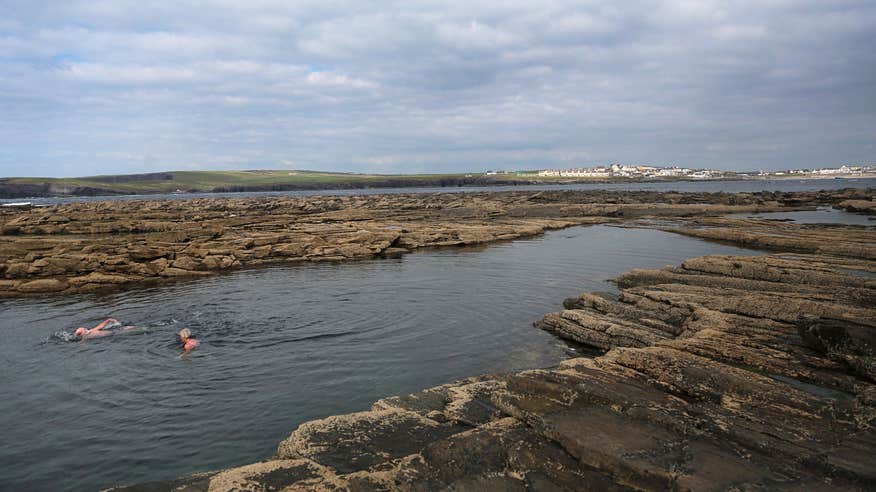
[{"xmin": 0, "ymin": 178, "xmax": 876, "ymax": 205}]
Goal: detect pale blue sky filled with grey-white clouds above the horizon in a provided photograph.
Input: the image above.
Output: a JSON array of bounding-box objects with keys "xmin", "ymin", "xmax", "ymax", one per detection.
[{"xmin": 0, "ymin": 0, "xmax": 876, "ymax": 177}]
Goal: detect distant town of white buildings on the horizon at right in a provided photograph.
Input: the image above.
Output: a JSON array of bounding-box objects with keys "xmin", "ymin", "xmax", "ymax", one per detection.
[{"xmin": 486, "ymin": 164, "xmax": 876, "ymax": 179}]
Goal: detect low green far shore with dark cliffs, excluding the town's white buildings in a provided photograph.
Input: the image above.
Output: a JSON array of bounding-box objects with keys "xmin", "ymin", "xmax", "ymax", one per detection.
[{"xmin": 0, "ymin": 171, "xmax": 876, "ymax": 199}]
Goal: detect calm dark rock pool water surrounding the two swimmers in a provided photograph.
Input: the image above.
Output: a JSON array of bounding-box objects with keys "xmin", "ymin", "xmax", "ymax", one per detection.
[{"xmin": 0, "ymin": 226, "xmax": 749, "ymax": 490}]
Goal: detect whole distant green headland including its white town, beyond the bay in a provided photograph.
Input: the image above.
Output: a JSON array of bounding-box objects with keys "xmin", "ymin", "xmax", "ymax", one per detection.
[{"xmin": 0, "ymin": 164, "xmax": 876, "ymax": 198}]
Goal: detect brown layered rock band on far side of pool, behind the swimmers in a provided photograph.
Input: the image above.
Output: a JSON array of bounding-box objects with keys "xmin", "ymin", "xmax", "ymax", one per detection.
[{"xmin": 0, "ymin": 190, "xmax": 873, "ymax": 297}]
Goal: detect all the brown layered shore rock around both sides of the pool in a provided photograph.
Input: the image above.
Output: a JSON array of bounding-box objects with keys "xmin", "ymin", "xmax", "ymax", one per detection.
[{"xmin": 0, "ymin": 190, "xmax": 876, "ymax": 491}]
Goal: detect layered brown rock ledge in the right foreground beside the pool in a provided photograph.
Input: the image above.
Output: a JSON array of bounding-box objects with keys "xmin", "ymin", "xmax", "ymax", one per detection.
[{"xmin": 117, "ymin": 248, "xmax": 876, "ymax": 491}]
